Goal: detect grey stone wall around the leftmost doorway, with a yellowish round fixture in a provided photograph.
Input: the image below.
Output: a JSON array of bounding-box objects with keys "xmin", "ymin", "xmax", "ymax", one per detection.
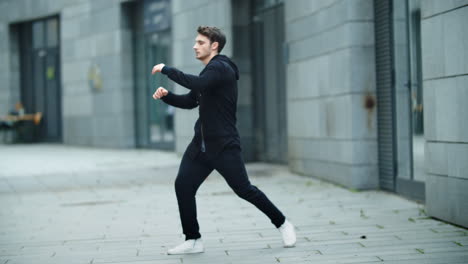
[{"xmin": 0, "ymin": 0, "xmax": 135, "ymax": 147}]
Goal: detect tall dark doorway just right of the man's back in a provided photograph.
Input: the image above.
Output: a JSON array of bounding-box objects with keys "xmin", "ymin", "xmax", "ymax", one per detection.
[{"xmin": 252, "ymin": 1, "xmax": 287, "ymax": 163}]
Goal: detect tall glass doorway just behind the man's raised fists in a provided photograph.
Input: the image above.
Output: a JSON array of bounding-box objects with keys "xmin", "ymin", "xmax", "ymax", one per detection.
[{"xmin": 122, "ymin": 0, "xmax": 175, "ymax": 150}]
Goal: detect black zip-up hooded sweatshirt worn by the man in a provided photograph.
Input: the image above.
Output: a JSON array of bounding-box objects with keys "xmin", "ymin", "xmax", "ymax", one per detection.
[{"xmin": 161, "ymin": 55, "xmax": 240, "ymax": 159}]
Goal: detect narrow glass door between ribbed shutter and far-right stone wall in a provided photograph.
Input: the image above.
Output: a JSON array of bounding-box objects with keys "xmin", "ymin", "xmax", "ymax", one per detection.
[{"xmin": 393, "ymin": 1, "xmax": 425, "ymax": 200}]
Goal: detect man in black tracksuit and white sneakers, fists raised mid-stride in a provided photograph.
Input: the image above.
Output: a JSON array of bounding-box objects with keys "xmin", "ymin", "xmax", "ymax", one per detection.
[{"xmin": 152, "ymin": 27, "xmax": 296, "ymax": 254}]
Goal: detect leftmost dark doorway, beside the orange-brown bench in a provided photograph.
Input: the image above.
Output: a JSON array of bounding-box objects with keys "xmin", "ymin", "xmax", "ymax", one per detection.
[{"xmin": 19, "ymin": 17, "xmax": 62, "ymax": 142}]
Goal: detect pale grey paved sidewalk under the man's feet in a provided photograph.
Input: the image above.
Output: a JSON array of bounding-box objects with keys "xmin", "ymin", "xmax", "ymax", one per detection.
[{"xmin": 0, "ymin": 144, "xmax": 468, "ymax": 264}]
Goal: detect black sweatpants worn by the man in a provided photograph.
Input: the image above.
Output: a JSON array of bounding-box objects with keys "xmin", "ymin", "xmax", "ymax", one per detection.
[{"xmin": 175, "ymin": 147, "xmax": 286, "ymax": 240}]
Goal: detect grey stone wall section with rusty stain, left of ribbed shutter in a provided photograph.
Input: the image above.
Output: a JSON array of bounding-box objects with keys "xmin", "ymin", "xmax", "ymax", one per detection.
[{"xmin": 285, "ymin": 0, "xmax": 378, "ymax": 189}]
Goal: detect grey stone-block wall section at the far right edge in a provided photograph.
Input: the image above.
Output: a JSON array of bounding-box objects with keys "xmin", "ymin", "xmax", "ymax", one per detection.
[{"xmin": 421, "ymin": 0, "xmax": 468, "ymax": 226}]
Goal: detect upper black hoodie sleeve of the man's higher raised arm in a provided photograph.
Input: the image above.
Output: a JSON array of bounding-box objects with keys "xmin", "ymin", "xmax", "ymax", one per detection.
[{"xmin": 161, "ymin": 65, "xmax": 222, "ymax": 93}]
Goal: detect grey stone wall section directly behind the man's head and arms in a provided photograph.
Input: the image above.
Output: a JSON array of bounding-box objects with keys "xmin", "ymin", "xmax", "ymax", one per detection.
[{"xmin": 172, "ymin": 0, "xmax": 232, "ymax": 153}]
